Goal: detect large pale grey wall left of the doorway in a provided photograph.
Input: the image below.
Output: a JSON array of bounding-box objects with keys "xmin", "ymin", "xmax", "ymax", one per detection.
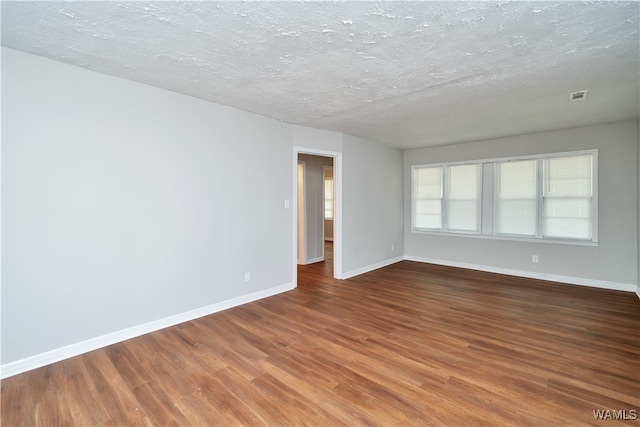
[{"xmin": 1, "ymin": 48, "xmax": 293, "ymax": 365}]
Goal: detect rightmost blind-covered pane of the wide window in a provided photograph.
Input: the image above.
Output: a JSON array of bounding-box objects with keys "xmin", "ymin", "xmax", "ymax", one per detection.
[{"xmin": 543, "ymin": 154, "xmax": 593, "ymax": 239}]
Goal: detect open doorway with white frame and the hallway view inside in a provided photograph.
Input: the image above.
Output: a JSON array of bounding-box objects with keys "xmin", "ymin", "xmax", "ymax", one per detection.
[{"xmin": 293, "ymin": 147, "xmax": 342, "ymax": 285}]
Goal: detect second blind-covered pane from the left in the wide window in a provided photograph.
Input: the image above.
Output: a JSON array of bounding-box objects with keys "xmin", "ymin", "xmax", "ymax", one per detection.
[{"xmin": 447, "ymin": 164, "xmax": 481, "ymax": 232}]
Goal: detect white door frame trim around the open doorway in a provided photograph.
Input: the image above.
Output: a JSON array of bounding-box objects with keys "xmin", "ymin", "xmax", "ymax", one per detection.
[{"xmin": 292, "ymin": 147, "xmax": 342, "ymax": 286}]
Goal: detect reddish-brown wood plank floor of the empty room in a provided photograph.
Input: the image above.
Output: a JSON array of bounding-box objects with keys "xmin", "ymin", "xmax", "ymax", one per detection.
[{"xmin": 1, "ymin": 246, "xmax": 640, "ymax": 426}]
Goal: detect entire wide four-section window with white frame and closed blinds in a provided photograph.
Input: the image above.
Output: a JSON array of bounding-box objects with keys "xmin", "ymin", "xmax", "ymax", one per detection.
[{"xmin": 412, "ymin": 150, "xmax": 597, "ymax": 243}]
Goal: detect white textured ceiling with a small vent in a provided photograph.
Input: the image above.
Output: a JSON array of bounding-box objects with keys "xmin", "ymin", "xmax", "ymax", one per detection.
[{"xmin": 1, "ymin": 1, "xmax": 640, "ymax": 148}]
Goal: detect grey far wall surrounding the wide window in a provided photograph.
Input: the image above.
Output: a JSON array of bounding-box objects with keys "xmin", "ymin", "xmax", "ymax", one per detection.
[{"xmin": 404, "ymin": 121, "xmax": 638, "ymax": 290}]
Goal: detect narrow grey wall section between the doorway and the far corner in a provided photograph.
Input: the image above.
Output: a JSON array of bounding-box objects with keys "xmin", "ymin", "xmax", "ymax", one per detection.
[{"xmin": 342, "ymin": 135, "xmax": 403, "ymax": 278}]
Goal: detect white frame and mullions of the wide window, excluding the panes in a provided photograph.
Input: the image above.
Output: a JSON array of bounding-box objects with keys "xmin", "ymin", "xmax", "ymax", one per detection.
[{"xmin": 410, "ymin": 149, "xmax": 598, "ymax": 246}]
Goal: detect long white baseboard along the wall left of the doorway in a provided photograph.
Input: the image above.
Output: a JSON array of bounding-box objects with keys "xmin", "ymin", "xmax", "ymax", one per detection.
[{"xmin": 0, "ymin": 283, "xmax": 295, "ymax": 379}]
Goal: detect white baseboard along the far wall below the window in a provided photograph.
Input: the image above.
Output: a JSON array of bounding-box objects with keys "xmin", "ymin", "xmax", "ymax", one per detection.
[{"xmin": 404, "ymin": 255, "xmax": 637, "ymax": 292}]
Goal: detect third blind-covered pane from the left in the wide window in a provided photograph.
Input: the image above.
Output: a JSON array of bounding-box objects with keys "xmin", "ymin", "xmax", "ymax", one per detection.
[{"xmin": 495, "ymin": 159, "xmax": 537, "ymax": 236}]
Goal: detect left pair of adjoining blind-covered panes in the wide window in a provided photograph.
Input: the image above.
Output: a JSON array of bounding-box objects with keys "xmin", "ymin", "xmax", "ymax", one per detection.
[{"xmin": 413, "ymin": 164, "xmax": 481, "ymax": 233}]
